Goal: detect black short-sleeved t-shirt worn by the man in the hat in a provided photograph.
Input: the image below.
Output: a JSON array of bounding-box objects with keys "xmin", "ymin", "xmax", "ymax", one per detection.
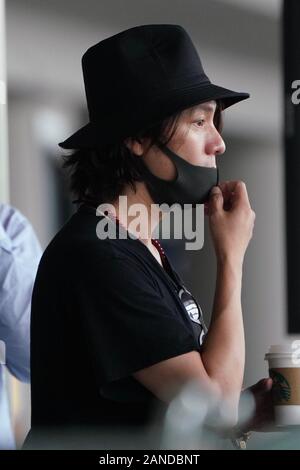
[{"xmin": 31, "ymin": 204, "xmax": 205, "ymax": 434}]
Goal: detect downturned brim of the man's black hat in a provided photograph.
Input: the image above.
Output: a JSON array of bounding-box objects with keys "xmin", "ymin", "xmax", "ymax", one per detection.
[{"xmin": 58, "ymin": 83, "xmax": 250, "ymax": 150}]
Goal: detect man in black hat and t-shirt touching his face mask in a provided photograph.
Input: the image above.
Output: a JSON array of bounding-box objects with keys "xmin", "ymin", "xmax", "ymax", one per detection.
[{"xmin": 26, "ymin": 25, "xmax": 270, "ymax": 448}]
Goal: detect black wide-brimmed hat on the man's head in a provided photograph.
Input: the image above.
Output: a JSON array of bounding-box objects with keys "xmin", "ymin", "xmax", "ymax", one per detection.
[{"xmin": 59, "ymin": 24, "xmax": 249, "ymax": 149}]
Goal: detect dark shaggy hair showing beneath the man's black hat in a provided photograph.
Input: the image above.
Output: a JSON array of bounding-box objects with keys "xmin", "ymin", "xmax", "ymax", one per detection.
[{"xmin": 62, "ymin": 101, "xmax": 223, "ymax": 205}]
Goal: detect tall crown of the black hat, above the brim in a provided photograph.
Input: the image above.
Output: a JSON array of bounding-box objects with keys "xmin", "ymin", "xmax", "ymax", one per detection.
[{"xmin": 82, "ymin": 24, "xmax": 210, "ymax": 122}]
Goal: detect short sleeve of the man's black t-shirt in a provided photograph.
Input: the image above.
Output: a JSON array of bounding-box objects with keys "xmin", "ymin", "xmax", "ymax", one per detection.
[{"xmin": 78, "ymin": 253, "xmax": 197, "ymax": 386}]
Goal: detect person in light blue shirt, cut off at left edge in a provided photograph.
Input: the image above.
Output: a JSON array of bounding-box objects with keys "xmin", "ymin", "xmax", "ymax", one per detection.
[{"xmin": 0, "ymin": 204, "xmax": 41, "ymax": 449}]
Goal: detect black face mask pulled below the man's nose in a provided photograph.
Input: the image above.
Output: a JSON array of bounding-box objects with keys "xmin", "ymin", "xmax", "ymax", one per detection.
[{"xmin": 138, "ymin": 144, "xmax": 219, "ymax": 207}]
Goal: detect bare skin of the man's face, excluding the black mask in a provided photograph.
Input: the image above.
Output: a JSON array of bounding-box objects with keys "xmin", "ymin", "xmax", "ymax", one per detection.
[{"xmin": 143, "ymin": 101, "xmax": 225, "ymax": 180}]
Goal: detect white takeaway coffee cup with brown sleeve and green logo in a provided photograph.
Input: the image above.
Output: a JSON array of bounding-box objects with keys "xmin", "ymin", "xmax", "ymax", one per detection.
[{"xmin": 265, "ymin": 343, "xmax": 300, "ymax": 426}]
